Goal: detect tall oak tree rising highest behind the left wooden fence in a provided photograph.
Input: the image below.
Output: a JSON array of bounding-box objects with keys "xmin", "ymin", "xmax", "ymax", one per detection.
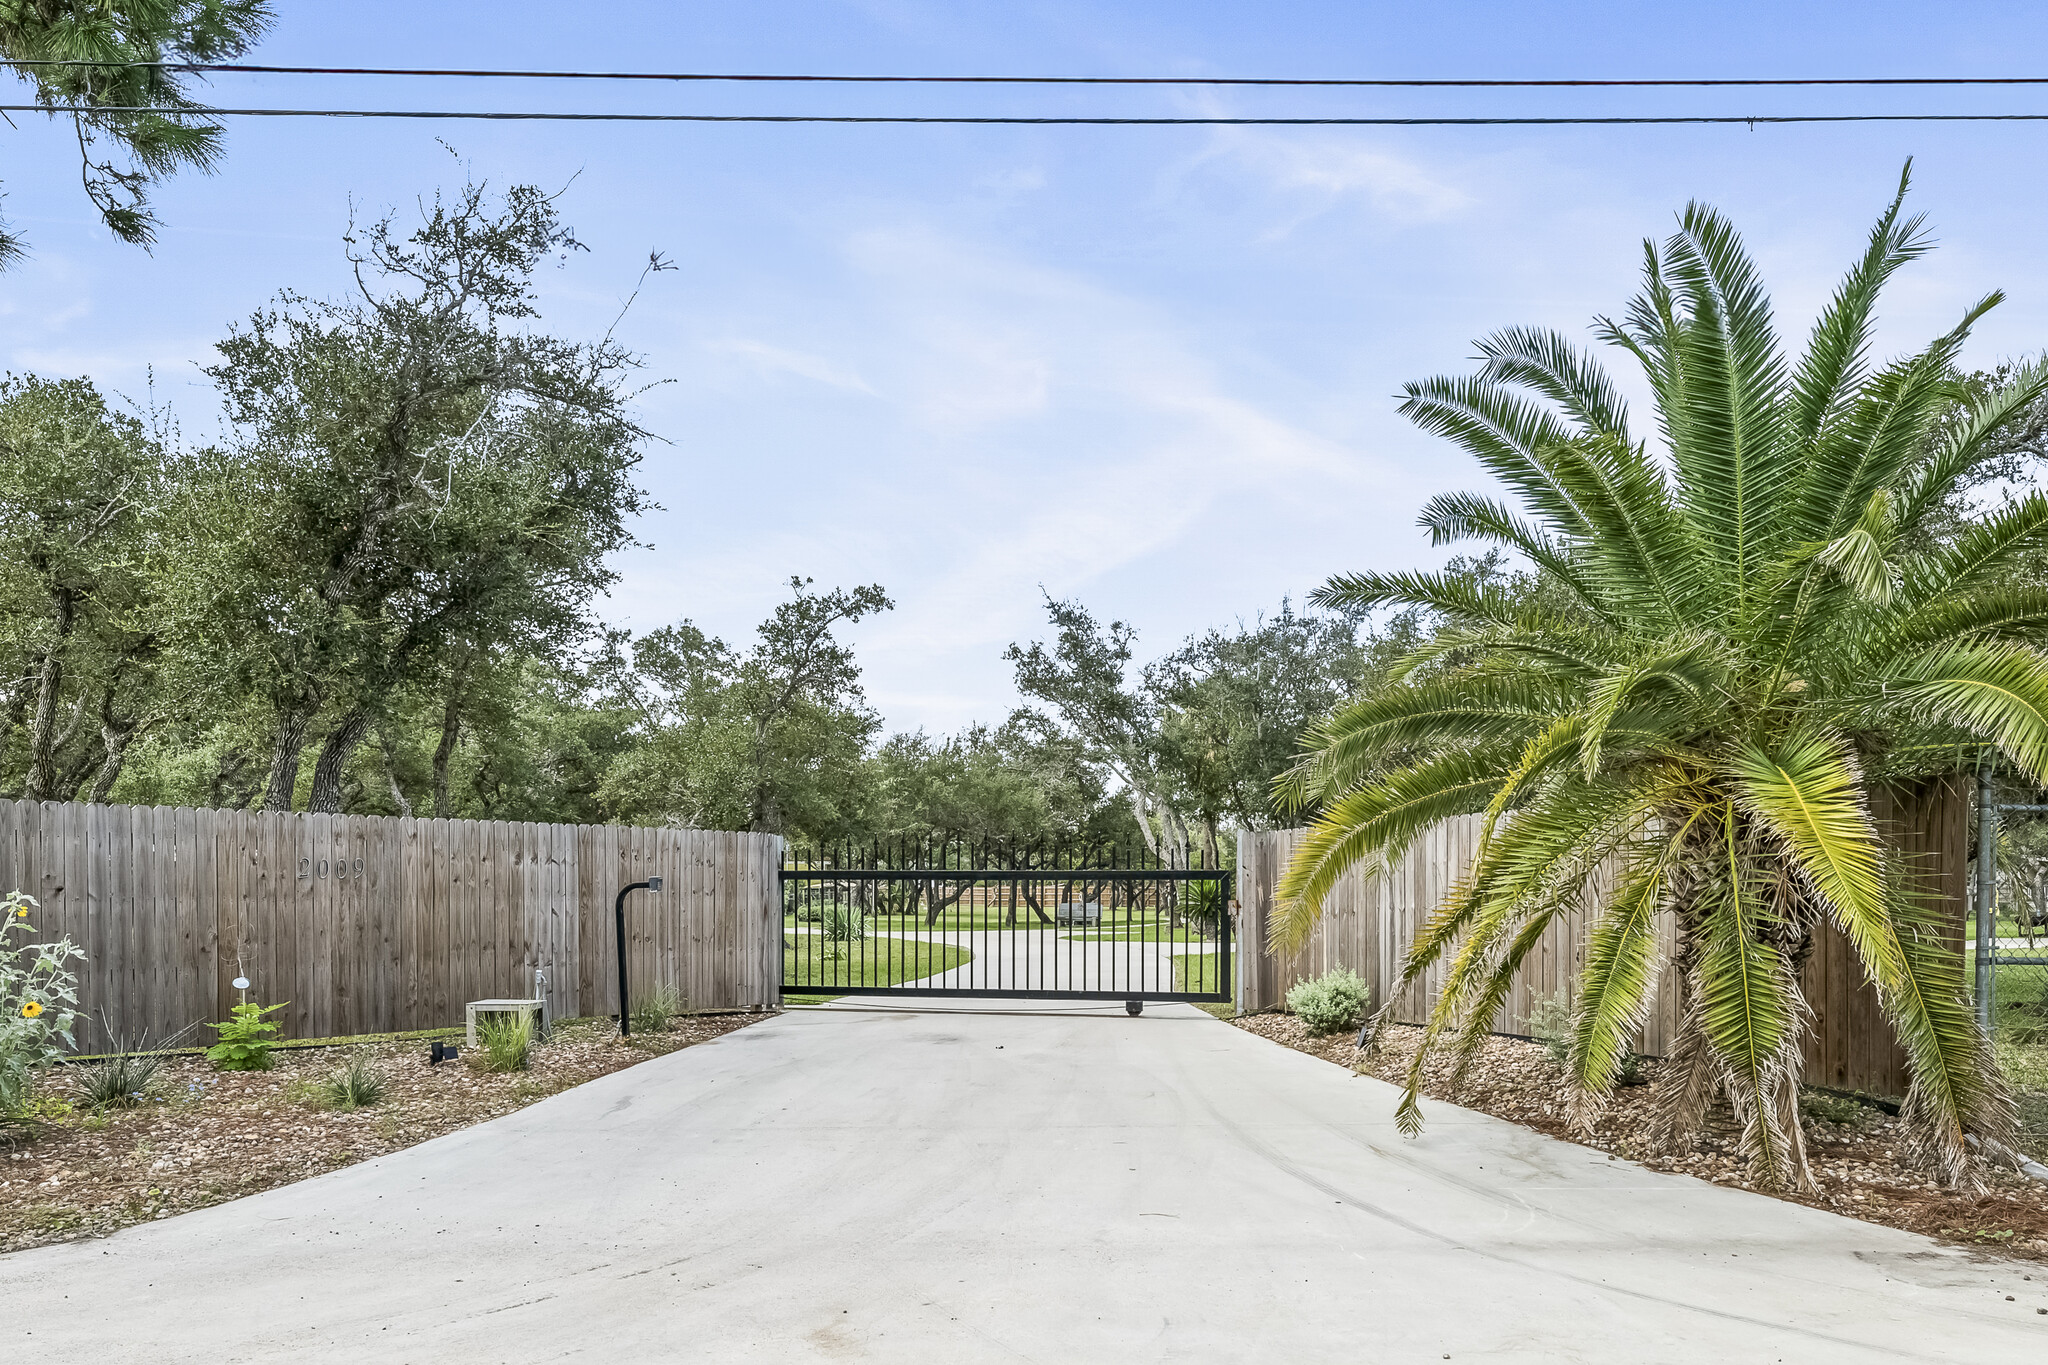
[{"xmin": 174, "ymin": 184, "xmax": 643, "ymax": 810}]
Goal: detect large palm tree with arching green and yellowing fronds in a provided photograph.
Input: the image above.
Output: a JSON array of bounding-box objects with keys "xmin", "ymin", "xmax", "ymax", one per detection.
[{"xmin": 1280, "ymin": 164, "xmax": 2048, "ymax": 1189}]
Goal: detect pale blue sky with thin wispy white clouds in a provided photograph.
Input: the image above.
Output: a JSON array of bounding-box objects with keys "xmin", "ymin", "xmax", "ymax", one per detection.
[{"xmin": 0, "ymin": 0, "xmax": 2048, "ymax": 731}]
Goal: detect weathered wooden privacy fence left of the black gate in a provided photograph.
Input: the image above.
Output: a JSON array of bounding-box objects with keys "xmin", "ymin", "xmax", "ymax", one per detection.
[{"xmin": 0, "ymin": 800, "xmax": 782, "ymax": 1052}]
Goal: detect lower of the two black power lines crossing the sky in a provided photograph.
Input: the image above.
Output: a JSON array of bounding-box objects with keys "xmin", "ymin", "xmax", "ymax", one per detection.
[{"xmin": 12, "ymin": 104, "xmax": 2048, "ymax": 127}]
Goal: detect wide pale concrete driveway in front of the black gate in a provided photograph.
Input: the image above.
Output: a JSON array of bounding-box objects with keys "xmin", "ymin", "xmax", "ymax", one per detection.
[{"xmin": 0, "ymin": 1005, "xmax": 2048, "ymax": 1365}]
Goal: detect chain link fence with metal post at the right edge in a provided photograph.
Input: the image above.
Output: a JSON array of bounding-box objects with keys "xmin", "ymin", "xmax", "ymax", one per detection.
[{"xmin": 1964, "ymin": 780, "xmax": 2048, "ymax": 1160}]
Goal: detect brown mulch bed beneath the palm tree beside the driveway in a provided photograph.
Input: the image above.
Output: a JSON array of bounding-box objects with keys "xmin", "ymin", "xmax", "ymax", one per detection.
[{"xmin": 1231, "ymin": 1015, "xmax": 2048, "ymax": 1261}]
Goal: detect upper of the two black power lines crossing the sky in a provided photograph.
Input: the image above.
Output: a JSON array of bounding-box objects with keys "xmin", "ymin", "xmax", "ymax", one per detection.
[{"xmin": 6, "ymin": 57, "xmax": 2048, "ymax": 90}]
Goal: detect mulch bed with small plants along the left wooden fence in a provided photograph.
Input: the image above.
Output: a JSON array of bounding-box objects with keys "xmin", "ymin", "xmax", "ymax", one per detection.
[{"xmin": 0, "ymin": 1015, "xmax": 766, "ymax": 1252}]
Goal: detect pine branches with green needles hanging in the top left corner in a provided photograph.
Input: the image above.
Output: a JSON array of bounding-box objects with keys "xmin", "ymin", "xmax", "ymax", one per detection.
[{"xmin": 0, "ymin": 0, "xmax": 272, "ymax": 270}]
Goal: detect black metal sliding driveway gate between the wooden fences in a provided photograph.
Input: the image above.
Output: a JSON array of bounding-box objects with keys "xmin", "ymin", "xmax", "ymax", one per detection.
[{"xmin": 782, "ymin": 841, "xmax": 1235, "ymax": 1011}]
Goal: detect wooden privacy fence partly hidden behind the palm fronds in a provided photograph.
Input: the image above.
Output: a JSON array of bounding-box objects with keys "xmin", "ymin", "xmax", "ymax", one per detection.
[{"xmin": 1237, "ymin": 780, "xmax": 1970, "ymax": 1095}]
